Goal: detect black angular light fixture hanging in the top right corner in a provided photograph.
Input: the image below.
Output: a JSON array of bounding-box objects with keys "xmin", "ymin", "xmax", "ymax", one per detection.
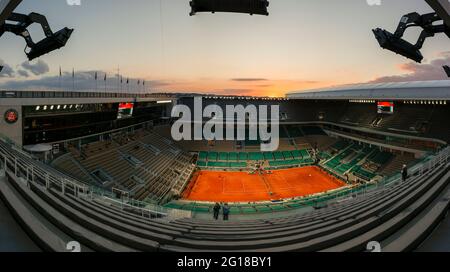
[{"xmin": 373, "ymin": 12, "xmax": 450, "ymax": 63}]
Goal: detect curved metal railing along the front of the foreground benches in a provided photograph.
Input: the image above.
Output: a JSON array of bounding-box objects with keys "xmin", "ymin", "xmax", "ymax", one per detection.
[{"xmin": 0, "ymin": 131, "xmax": 450, "ymax": 222}]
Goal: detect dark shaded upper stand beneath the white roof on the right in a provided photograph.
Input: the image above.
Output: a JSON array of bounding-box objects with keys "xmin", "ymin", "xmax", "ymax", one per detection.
[{"xmin": 181, "ymin": 98, "xmax": 450, "ymax": 144}]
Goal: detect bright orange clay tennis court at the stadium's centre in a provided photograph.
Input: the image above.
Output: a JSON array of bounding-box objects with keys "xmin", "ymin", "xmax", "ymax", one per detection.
[{"xmin": 183, "ymin": 167, "xmax": 345, "ymax": 202}]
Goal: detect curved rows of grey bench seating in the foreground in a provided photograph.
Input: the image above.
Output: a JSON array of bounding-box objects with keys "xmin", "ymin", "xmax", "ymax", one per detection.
[{"xmin": 0, "ymin": 136, "xmax": 450, "ymax": 252}]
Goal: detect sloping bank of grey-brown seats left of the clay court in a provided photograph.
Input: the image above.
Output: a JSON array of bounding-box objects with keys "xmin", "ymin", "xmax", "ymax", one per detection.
[{"xmin": 53, "ymin": 131, "xmax": 195, "ymax": 202}]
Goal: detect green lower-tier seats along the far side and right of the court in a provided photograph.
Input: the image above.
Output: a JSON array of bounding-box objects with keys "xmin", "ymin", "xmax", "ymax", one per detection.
[{"xmin": 197, "ymin": 139, "xmax": 400, "ymax": 181}]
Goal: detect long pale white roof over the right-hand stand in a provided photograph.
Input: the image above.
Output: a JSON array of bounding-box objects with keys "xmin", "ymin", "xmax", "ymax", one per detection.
[{"xmin": 287, "ymin": 80, "xmax": 450, "ymax": 100}]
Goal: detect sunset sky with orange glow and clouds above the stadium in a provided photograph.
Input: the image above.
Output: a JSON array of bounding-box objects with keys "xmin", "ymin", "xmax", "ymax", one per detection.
[{"xmin": 0, "ymin": 0, "xmax": 450, "ymax": 96}]
